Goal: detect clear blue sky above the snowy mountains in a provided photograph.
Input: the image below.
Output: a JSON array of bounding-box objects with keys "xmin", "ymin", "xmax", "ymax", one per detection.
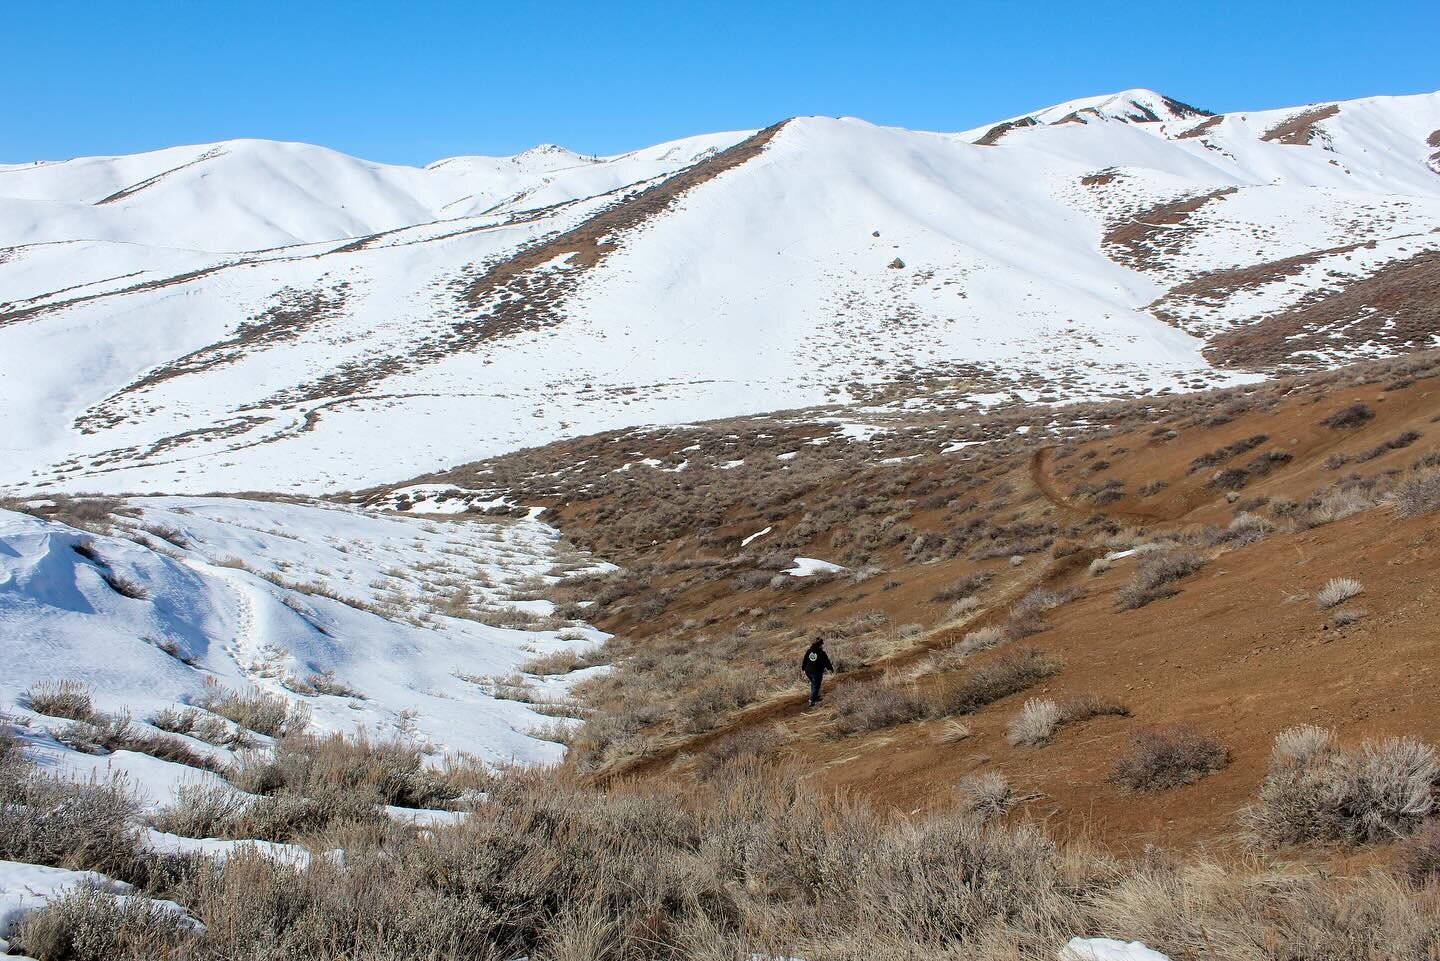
[{"xmin": 0, "ymin": 0, "xmax": 1440, "ymax": 163}]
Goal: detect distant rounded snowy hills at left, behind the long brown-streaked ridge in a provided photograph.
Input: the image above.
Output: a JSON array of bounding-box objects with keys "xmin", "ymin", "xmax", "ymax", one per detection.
[{"xmin": 0, "ymin": 133, "xmax": 744, "ymax": 252}]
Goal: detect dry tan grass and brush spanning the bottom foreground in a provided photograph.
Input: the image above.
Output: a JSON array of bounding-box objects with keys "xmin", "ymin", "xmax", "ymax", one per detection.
[{"xmin": 0, "ymin": 720, "xmax": 1440, "ymax": 961}]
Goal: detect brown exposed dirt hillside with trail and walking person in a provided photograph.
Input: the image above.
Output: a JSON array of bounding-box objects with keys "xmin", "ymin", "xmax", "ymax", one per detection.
[{"xmin": 400, "ymin": 356, "xmax": 1440, "ymax": 856}]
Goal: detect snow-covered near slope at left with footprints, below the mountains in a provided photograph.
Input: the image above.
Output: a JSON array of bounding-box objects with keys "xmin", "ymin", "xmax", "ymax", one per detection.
[{"xmin": 0, "ymin": 499, "xmax": 605, "ymax": 783}]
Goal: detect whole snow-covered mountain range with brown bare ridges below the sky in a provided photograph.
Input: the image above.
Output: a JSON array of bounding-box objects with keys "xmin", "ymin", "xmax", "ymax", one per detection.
[{"xmin": 0, "ymin": 91, "xmax": 1440, "ymax": 491}]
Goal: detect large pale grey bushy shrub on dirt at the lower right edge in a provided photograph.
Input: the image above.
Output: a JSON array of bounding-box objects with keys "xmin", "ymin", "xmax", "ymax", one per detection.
[{"xmin": 1243, "ymin": 728, "xmax": 1440, "ymax": 847}]
